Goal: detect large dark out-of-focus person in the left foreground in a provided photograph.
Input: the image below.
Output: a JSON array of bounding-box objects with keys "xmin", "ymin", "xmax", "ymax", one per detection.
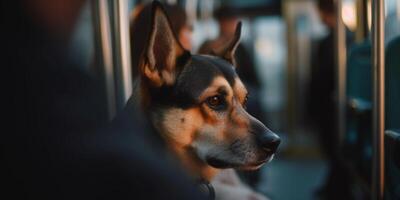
[{"xmin": 0, "ymin": 0, "xmax": 205, "ymax": 199}]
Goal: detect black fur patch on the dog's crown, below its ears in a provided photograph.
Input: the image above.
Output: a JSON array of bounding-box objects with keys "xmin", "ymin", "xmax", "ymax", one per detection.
[{"xmin": 151, "ymin": 55, "xmax": 237, "ymax": 109}]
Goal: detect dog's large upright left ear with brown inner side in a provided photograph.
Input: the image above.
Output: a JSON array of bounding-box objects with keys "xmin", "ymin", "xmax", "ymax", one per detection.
[{"xmin": 139, "ymin": 1, "xmax": 190, "ymax": 87}]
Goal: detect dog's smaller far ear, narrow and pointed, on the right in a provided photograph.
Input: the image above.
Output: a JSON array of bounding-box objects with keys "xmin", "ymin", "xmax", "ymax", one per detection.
[{"xmin": 215, "ymin": 22, "xmax": 242, "ymax": 66}]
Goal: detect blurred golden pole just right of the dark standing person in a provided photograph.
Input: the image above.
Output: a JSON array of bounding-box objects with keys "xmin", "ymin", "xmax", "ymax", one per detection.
[{"xmin": 335, "ymin": 0, "xmax": 347, "ymax": 148}]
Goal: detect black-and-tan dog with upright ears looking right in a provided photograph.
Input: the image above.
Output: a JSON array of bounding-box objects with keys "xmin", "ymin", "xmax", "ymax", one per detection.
[{"xmin": 128, "ymin": 2, "xmax": 280, "ymax": 181}]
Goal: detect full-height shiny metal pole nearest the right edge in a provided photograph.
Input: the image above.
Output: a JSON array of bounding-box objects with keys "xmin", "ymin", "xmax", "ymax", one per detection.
[{"xmin": 372, "ymin": 0, "xmax": 385, "ymax": 199}]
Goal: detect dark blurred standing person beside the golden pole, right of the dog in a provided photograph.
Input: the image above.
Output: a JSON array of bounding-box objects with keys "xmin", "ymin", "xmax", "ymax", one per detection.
[{"xmin": 309, "ymin": 0, "xmax": 352, "ymax": 199}]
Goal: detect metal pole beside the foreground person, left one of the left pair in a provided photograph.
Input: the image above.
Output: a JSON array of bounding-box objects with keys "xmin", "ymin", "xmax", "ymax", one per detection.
[{"xmin": 91, "ymin": 0, "xmax": 116, "ymax": 119}]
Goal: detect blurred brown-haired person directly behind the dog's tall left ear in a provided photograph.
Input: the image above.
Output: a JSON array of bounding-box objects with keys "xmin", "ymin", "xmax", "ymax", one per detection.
[{"xmin": 130, "ymin": 3, "xmax": 193, "ymax": 81}]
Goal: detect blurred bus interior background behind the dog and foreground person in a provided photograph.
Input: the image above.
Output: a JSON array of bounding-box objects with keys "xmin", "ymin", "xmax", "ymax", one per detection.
[{"xmin": 6, "ymin": 0, "xmax": 400, "ymax": 200}]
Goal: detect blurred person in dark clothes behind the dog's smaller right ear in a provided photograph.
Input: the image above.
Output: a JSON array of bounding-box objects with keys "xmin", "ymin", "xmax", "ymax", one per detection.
[{"xmin": 199, "ymin": 6, "xmax": 265, "ymax": 187}]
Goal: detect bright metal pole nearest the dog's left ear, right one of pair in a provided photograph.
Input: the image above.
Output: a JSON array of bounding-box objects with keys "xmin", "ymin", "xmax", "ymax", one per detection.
[{"xmin": 111, "ymin": 0, "xmax": 132, "ymax": 110}]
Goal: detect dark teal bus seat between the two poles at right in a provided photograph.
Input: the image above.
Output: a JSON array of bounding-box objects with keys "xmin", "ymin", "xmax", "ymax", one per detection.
[{"xmin": 344, "ymin": 40, "xmax": 372, "ymax": 180}]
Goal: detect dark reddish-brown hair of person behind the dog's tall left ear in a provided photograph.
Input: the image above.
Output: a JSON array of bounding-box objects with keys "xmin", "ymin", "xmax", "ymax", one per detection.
[{"xmin": 130, "ymin": 4, "xmax": 187, "ymax": 77}]
